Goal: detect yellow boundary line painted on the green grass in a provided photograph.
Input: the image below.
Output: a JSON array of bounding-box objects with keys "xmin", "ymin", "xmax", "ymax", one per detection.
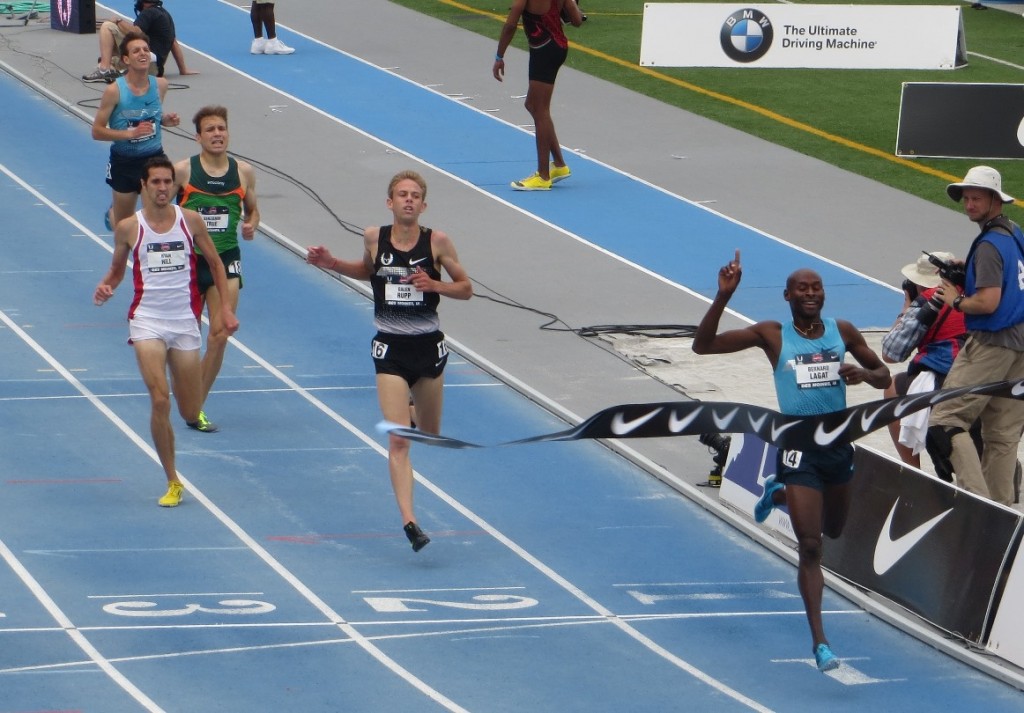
[{"xmin": 437, "ymin": 0, "xmax": 959, "ymax": 182}]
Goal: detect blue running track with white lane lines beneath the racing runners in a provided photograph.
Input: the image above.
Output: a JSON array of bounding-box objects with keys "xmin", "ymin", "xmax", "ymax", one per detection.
[{"xmin": 0, "ymin": 0, "xmax": 1021, "ymax": 713}]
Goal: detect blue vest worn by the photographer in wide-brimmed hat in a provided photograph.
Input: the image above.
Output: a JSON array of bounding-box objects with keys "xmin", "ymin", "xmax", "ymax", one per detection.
[{"xmin": 964, "ymin": 215, "xmax": 1024, "ymax": 332}]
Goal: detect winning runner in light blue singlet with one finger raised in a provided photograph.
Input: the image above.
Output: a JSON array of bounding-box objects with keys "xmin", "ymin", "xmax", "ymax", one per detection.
[{"xmin": 693, "ymin": 250, "xmax": 892, "ymax": 671}]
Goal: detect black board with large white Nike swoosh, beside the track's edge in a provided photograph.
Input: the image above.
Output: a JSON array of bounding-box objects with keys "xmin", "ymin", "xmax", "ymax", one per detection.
[{"xmin": 821, "ymin": 449, "xmax": 1022, "ymax": 644}]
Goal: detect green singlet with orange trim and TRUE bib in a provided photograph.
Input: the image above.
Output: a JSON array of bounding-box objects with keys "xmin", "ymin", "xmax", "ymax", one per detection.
[{"xmin": 178, "ymin": 155, "xmax": 246, "ymax": 253}]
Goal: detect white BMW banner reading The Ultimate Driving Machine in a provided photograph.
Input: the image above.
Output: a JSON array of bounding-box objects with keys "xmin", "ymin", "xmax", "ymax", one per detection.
[{"xmin": 640, "ymin": 3, "xmax": 967, "ymax": 70}]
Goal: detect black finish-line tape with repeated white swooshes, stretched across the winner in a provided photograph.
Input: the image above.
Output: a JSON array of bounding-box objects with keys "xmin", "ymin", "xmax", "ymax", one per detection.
[{"xmin": 377, "ymin": 380, "xmax": 1024, "ymax": 451}]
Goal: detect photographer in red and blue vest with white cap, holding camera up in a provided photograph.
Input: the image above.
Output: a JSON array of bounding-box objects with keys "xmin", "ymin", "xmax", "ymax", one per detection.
[{"xmin": 882, "ymin": 252, "xmax": 967, "ymax": 471}]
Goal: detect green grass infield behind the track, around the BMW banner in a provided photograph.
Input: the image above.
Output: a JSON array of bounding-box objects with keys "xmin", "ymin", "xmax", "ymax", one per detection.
[{"xmin": 392, "ymin": 0, "xmax": 1024, "ymax": 220}]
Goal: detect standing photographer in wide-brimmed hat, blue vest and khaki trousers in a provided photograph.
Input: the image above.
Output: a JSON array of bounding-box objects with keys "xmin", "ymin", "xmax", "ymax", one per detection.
[{"xmin": 928, "ymin": 166, "xmax": 1024, "ymax": 505}]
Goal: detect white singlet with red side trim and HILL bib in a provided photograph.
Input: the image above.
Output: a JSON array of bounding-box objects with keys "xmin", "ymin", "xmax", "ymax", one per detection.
[{"xmin": 128, "ymin": 205, "xmax": 203, "ymax": 320}]
